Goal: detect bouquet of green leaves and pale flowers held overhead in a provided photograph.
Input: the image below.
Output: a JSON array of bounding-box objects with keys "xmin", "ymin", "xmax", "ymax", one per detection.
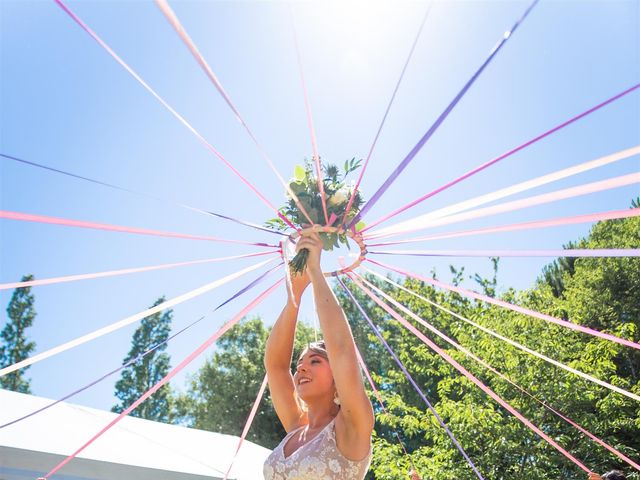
[{"xmin": 265, "ymin": 158, "xmax": 364, "ymax": 275}]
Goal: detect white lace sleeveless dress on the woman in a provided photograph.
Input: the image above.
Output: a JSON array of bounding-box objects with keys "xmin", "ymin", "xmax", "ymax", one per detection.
[{"xmin": 263, "ymin": 418, "xmax": 371, "ymax": 480}]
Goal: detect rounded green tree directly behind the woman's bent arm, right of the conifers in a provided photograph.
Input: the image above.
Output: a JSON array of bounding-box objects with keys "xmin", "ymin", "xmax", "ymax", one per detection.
[{"xmin": 177, "ymin": 318, "xmax": 315, "ymax": 448}]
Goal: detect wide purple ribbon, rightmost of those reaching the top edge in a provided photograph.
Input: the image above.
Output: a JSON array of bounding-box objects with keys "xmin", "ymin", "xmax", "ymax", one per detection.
[{"xmin": 349, "ymin": 0, "xmax": 538, "ymax": 231}]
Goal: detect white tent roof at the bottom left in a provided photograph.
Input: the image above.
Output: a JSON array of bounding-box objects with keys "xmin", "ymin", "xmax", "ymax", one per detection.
[{"xmin": 0, "ymin": 389, "xmax": 270, "ymax": 480}]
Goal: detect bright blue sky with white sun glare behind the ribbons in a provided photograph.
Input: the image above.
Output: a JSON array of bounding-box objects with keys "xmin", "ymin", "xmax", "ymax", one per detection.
[{"xmin": 0, "ymin": 0, "xmax": 640, "ymax": 408}]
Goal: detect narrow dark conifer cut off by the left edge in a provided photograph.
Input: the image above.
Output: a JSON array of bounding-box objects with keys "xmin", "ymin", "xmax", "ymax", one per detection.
[{"xmin": 0, "ymin": 275, "xmax": 36, "ymax": 393}]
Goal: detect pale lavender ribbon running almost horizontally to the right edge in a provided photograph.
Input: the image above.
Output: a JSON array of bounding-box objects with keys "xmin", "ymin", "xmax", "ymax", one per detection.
[{"xmin": 369, "ymin": 248, "xmax": 640, "ymax": 257}]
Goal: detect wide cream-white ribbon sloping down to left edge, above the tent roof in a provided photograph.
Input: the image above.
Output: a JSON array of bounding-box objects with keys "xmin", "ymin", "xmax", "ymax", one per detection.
[{"xmin": 0, "ymin": 258, "xmax": 277, "ymax": 377}]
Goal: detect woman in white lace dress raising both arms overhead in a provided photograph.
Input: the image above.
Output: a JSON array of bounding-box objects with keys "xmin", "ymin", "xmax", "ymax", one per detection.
[{"xmin": 264, "ymin": 231, "xmax": 374, "ymax": 480}]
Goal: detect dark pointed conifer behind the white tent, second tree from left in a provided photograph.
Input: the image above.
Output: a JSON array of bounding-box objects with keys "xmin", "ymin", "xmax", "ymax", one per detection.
[{"xmin": 111, "ymin": 296, "xmax": 173, "ymax": 422}]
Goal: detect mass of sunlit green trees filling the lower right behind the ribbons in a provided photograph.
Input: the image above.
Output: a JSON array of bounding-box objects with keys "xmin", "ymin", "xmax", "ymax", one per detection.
[{"xmin": 338, "ymin": 218, "xmax": 640, "ymax": 480}]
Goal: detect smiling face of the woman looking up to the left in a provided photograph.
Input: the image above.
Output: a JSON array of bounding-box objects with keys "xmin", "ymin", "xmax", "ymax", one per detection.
[{"xmin": 293, "ymin": 346, "xmax": 336, "ymax": 403}]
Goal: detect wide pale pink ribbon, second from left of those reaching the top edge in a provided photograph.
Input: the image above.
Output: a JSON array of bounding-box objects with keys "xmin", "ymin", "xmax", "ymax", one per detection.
[{"xmin": 156, "ymin": 0, "xmax": 314, "ymax": 225}]
